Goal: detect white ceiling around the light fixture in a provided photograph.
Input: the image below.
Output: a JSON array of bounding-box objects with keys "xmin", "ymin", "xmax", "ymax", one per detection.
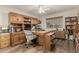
[{"xmin": 5, "ymin": 5, "xmax": 78, "ymax": 17}]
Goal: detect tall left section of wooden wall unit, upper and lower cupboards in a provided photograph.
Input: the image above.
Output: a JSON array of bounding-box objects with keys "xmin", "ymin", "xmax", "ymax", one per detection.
[{"xmin": 9, "ymin": 12, "xmax": 25, "ymax": 46}]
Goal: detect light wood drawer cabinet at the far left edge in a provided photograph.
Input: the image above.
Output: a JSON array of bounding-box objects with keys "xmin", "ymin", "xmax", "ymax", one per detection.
[{"xmin": 0, "ymin": 33, "xmax": 10, "ymax": 48}]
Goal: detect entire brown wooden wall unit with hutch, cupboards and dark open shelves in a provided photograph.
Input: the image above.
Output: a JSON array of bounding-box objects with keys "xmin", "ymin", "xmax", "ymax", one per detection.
[{"xmin": 9, "ymin": 12, "xmax": 39, "ymax": 46}]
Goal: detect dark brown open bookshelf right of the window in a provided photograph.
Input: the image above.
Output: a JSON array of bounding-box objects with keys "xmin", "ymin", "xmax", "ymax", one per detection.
[{"xmin": 65, "ymin": 16, "xmax": 78, "ymax": 35}]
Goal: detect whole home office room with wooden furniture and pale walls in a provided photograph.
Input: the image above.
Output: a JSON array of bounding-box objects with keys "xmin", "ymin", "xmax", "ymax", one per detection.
[{"xmin": 0, "ymin": 5, "xmax": 79, "ymax": 53}]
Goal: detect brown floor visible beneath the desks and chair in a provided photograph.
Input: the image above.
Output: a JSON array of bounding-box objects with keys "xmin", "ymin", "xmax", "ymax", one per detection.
[{"xmin": 0, "ymin": 40, "xmax": 78, "ymax": 53}]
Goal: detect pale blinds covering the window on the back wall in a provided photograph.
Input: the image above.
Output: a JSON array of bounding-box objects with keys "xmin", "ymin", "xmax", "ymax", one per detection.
[{"xmin": 46, "ymin": 16, "xmax": 63, "ymax": 28}]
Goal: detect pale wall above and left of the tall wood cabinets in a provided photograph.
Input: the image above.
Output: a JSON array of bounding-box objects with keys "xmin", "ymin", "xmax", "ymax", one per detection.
[{"xmin": 0, "ymin": 6, "xmax": 35, "ymax": 27}]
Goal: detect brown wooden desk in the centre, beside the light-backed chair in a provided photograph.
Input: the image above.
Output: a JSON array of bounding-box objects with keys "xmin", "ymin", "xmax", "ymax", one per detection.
[{"xmin": 33, "ymin": 31, "xmax": 52, "ymax": 51}]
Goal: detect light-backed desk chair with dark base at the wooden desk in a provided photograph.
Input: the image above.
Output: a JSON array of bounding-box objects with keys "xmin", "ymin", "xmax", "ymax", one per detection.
[{"xmin": 24, "ymin": 30, "xmax": 37, "ymax": 48}]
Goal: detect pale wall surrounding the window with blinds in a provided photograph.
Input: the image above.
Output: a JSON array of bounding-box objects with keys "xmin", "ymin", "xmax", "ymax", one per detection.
[{"xmin": 40, "ymin": 9, "xmax": 78, "ymax": 29}]
